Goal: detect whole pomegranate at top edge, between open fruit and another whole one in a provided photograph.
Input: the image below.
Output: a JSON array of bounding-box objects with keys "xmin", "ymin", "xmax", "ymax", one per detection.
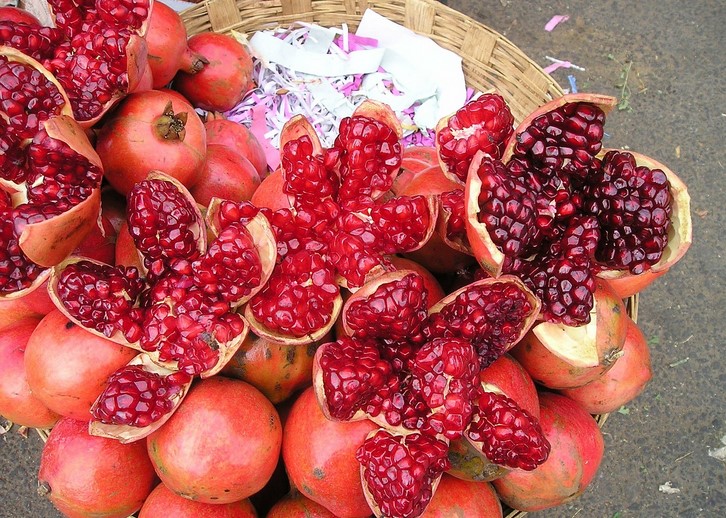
[{"xmin": 146, "ymin": 2, "xmax": 208, "ymax": 89}]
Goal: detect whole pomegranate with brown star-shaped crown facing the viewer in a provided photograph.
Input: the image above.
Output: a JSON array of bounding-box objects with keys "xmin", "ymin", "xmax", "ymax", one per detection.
[{"xmin": 96, "ymin": 90, "xmax": 207, "ymax": 195}]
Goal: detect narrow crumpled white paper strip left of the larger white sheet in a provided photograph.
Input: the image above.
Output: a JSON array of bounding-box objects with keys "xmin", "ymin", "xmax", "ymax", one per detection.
[{"xmin": 250, "ymin": 31, "xmax": 384, "ymax": 77}]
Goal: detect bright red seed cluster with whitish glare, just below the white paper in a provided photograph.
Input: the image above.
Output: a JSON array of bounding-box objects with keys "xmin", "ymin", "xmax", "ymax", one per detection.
[{"xmin": 436, "ymin": 94, "xmax": 514, "ymax": 183}]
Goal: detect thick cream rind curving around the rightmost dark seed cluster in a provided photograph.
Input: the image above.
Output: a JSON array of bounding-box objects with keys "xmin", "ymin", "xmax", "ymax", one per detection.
[{"xmin": 598, "ymin": 149, "xmax": 693, "ymax": 286}]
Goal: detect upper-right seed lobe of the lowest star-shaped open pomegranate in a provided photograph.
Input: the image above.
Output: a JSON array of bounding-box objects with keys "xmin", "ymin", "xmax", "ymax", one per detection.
[{"xmin": 426, "ymin": 282, "xmax": 534, "ymax": 368}]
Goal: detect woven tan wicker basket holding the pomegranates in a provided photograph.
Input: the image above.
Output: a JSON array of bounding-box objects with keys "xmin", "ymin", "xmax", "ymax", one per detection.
[{"xmin": 181, "ymin": 0, "xmax": 638, "ymax": 518}]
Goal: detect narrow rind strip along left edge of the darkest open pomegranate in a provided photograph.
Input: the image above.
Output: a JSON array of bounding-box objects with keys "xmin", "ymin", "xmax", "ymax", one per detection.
[{"xmin": 464, "ymin": 151, "xmax": 505, "ymax": 277}]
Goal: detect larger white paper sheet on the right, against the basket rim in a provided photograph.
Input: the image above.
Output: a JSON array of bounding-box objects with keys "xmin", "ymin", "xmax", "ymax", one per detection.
[{"xmin": 356, "ymin": 9, "xmax": 466, "ymax": 122}]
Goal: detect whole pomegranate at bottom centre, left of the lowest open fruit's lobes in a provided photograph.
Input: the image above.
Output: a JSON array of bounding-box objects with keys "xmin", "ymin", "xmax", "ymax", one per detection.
[{"xmin": 282, "ymin": 388, "xmax": 377, "ymax": 518}]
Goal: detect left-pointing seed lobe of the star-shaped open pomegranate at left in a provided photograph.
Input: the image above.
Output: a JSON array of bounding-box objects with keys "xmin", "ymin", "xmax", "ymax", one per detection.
[{"xmin": 56, "ymin": 260, "xmax": 146, "ymax": 343}]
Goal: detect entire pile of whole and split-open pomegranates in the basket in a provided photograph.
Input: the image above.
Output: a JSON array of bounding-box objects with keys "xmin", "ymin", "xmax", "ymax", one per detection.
[{"xmin": 0, "ymin": 0, "xmax": 691, "ymax": 518}]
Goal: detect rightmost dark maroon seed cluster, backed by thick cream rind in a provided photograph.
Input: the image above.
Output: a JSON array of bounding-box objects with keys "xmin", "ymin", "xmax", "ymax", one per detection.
[{"xmin": 586, "ymin": 151, "xmax": 673, "ymax": 275}]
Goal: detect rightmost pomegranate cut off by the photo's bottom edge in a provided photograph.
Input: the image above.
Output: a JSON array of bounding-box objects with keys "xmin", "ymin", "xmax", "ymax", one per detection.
[{"xmin": 421, "ymin": 473, "xmax": 503, "ymax": 518}]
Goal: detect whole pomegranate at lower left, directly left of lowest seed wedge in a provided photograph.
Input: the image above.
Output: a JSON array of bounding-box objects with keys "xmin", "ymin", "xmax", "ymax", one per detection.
[{"xmin": 25, "ymin": 310, "xmax": 136, "ymax": 421}]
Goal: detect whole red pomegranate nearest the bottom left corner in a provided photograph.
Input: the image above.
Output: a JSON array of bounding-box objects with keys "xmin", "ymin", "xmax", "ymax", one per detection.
[{"xmin": 38, "ymin": 418, "xmax": 156, "ymax": 518}]
